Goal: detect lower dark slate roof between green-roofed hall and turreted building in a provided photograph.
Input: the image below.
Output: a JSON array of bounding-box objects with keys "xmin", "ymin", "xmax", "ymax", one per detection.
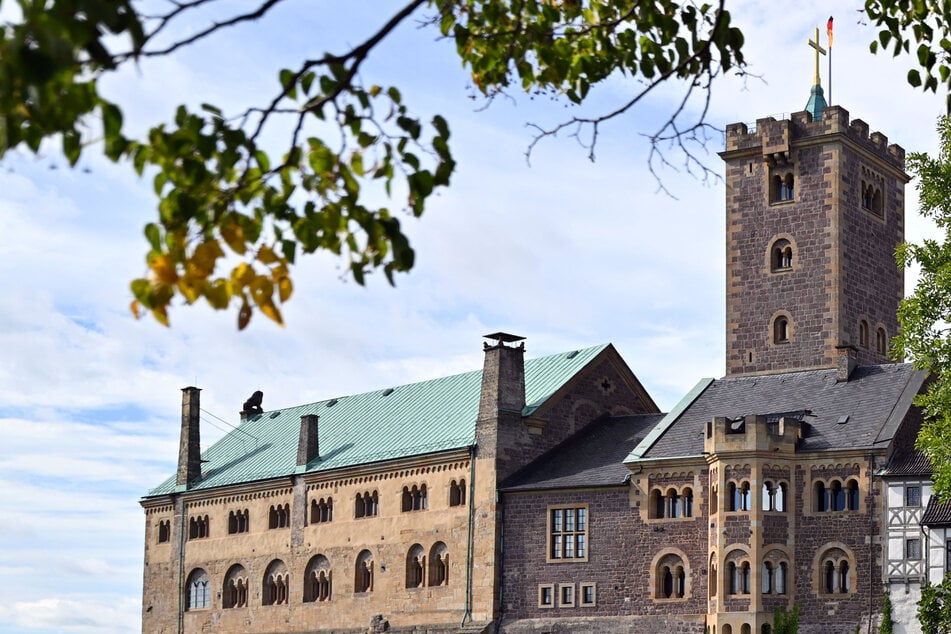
[{"xmin": 499, "ymin": 414, "xmax": 664, "ymax": 491}]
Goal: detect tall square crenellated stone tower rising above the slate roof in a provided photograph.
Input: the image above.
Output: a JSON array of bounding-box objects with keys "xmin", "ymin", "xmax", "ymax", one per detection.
[{"xmin": 720, "ymin": 106, "xmax": 908, "ymax": 376}]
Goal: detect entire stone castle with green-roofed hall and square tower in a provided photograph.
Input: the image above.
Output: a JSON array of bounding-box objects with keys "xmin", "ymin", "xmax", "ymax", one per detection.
[{"xmin": 141, "ymin": 89, "xmax": 951, "ymax": 634}]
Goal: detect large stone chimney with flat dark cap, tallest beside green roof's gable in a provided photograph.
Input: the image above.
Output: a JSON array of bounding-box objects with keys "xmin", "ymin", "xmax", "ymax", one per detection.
[{"xmin": 479, "ymin": 332, "xmax": 525, "ymax": 419}]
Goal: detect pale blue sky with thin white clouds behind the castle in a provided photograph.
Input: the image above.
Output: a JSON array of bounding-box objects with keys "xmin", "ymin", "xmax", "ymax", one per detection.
[{"xmin": 0, "ymin": 0, "xmax": 944, "ymax": 633}]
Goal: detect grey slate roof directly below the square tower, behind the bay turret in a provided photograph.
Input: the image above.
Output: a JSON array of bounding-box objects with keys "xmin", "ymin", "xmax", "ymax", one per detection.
[{"xmin": 627, "ymin": 364, "xmax": 925, "ymax": 462}]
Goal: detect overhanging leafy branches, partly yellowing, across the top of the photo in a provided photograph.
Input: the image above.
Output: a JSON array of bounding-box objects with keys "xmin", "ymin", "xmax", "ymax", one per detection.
[{"xmin": 0, "ymin": 0, "xmax": 951, "ymax": 328}]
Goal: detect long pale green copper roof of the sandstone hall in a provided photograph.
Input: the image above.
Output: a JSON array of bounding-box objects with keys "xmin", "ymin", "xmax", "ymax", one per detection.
[{"xmin": 146, "ymin": 344, "xmax": 607, "ymax": 497}]
